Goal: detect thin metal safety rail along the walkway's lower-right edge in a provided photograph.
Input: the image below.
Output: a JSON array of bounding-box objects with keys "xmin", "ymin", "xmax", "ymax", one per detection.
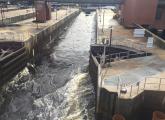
[{"xmin": 103, "ymin": 77, "xmax": 165, "ymax": 98}]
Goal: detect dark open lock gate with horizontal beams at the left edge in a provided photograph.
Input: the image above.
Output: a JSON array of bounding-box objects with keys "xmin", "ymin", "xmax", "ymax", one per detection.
[{"xmin": 0, "ymin": 47, "xmax": 28, "ymax": 85}]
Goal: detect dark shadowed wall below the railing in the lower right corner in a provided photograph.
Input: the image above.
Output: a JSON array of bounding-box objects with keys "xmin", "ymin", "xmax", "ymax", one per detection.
[{"xmin": 114, "ymin": 91, "xmax": 165, "ymax": 120}]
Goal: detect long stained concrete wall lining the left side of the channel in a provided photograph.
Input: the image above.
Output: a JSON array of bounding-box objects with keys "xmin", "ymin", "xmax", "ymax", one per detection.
[{"xmin": 24, "ymin": 11, "xmax": 80, "ymax": 63}]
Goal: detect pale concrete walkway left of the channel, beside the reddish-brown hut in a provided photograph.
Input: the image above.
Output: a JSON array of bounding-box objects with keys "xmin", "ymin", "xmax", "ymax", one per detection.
[{"xmin": 0, "ymin": 9, "xmax": 78, "ymax": 41}]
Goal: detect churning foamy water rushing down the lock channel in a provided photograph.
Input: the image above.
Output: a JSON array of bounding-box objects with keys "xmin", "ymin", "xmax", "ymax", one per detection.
[{"xmin": 0, "ymin": 13, "xmax": 95, "ymax": 120}]
